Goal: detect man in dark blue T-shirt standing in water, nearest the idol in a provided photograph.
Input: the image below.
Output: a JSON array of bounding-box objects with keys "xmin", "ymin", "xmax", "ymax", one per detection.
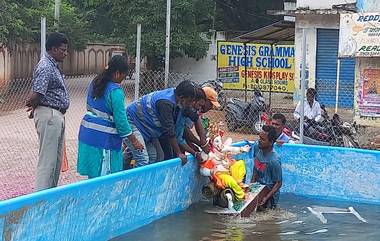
[{"xmin": 252, "ymin": 126, "xmax": 282, "ymax": 209}]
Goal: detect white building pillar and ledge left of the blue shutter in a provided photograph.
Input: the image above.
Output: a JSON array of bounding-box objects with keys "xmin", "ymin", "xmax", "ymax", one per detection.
[{"xmin": 293, "ymin": 15, "xmax": 339, "ymax": 103}]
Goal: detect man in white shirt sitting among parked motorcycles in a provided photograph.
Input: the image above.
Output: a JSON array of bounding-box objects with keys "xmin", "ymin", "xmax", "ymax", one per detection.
[{"xmin": 293, "ymin": 88, "xmax": 322, "ymax": 123}]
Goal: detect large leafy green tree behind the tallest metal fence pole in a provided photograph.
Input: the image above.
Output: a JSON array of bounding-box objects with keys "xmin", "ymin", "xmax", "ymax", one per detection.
[{"xmin": 83, "ymin": 0, "xmax": 212, "ymax": 69}]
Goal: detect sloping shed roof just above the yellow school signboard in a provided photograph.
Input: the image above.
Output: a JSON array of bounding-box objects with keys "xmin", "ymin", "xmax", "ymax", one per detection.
[{"xmin": 232, "ymin": 20, "xmax": 295, "ymax": 44}]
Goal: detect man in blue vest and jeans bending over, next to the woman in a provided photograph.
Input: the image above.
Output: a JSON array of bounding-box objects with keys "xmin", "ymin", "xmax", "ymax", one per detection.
[{"xmin": 126, "ymin": 80, "xmax": 195, "ymax": 166}]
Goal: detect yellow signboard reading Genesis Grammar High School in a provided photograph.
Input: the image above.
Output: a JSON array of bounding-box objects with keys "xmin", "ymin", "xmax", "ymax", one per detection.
[{"xmin": 217, "ymin": 41, "xmax": 294, "ymax": 93}]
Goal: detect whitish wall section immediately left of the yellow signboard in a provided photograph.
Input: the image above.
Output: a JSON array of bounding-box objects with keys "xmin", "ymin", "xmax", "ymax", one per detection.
[{"xmin": 170, "ymin": 32, "xmax": 226, "ymax": 82}]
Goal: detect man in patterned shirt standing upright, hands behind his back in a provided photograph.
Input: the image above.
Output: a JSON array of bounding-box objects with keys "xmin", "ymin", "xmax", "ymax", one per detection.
[{"xmin": 26, "ymin": 32, "xmax": 70, "ymax": 191}]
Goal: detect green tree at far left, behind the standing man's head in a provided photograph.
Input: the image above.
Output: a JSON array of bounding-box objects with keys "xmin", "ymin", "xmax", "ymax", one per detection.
[{"xmin": 0, "ymin": 0, "xmax": 89, "ymax": 49}]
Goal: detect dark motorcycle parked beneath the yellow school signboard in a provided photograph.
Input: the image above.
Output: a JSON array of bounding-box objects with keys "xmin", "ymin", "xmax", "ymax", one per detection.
[{"xmin": 226, "ymin": 89, "xmax": 269, "ymax": 134}]
